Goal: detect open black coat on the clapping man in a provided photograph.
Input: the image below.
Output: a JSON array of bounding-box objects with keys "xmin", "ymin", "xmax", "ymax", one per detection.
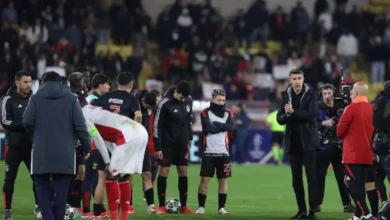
[{"xmin": 277, "ymin": 84, "xmax": 319, "ymax": 152}]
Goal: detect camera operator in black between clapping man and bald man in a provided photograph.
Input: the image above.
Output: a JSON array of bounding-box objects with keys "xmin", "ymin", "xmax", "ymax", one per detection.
[{"xmin": 316, "ymin": 84, "xmax": 355, "ymax": 212}]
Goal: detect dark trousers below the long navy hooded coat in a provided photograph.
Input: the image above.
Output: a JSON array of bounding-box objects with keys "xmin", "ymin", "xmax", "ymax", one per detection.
[{"xmin": 34, "ymin": 174, "xmax": 74, "ymax": 220}]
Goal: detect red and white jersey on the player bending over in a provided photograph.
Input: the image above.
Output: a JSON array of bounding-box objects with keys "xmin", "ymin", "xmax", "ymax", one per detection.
[{"xmin": 82, "ymin": 105, "xmax": 146, "ymax": 163}]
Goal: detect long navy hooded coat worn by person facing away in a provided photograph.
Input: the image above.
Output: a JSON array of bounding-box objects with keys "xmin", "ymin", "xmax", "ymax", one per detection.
[{"xmin": 23, "ymin": 82, "xmax": 91, "ymax": 175}]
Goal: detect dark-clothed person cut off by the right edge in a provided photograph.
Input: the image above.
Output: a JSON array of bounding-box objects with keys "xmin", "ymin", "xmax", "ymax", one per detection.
[{"xmin": 373, "ymin": 81, "xmax": 390, "ymax": 200}]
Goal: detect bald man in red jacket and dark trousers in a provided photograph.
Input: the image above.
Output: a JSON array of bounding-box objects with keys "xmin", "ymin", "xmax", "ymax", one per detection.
[{"xmin": 337, "ymin": 82, "xmax": 375, "ymax": 220}]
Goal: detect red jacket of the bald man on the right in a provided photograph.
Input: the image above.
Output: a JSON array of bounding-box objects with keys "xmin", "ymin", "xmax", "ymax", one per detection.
[{"xmin": 337, "ymin": 96, "xmax": 375, "ymax": 164}]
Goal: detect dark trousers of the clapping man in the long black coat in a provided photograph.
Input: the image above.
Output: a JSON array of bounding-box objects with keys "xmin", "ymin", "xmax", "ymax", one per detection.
[{"xmin": 290, "ymin": 150, "xmax": 318, "ymax": 212}]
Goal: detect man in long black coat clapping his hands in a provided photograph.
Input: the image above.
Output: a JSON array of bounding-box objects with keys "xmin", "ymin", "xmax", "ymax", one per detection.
[{"xmin": 277, "ymin": 69, "xmax": 319, "ymax": 219}]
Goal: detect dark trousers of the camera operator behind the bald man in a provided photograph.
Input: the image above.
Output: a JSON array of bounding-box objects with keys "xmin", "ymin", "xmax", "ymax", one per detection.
[{"xmin": 316, "ymin": 148, "xmax": 351, "ymax": 206}]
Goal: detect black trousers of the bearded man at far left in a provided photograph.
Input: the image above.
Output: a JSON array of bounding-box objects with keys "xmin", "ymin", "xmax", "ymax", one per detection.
[{"xmin": 3, "ymin": 146, "xmax": 38, "ymax": 209}]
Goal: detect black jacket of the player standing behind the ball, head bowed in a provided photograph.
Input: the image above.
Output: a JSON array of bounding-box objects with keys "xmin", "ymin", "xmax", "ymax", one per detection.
[{"xmin": 153, "ymin": 88, "xmax": 192, "ymax": 151}]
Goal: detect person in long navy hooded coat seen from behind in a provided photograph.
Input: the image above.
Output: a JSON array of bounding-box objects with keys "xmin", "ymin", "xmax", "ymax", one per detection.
[{"xmin": 23, "ymin": 72, "xmax": 91, "ymax": 220}]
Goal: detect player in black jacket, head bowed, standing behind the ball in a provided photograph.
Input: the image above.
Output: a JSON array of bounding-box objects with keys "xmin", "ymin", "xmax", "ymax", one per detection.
[{"xmin": 153, "ymin": 81, "xmax": 193, "ymax": 214}]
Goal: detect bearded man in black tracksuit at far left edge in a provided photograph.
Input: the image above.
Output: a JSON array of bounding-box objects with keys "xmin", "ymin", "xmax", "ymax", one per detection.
[{"xmin": 1, "ymin": 70, "xmax": 39, "ymax": 219}]
